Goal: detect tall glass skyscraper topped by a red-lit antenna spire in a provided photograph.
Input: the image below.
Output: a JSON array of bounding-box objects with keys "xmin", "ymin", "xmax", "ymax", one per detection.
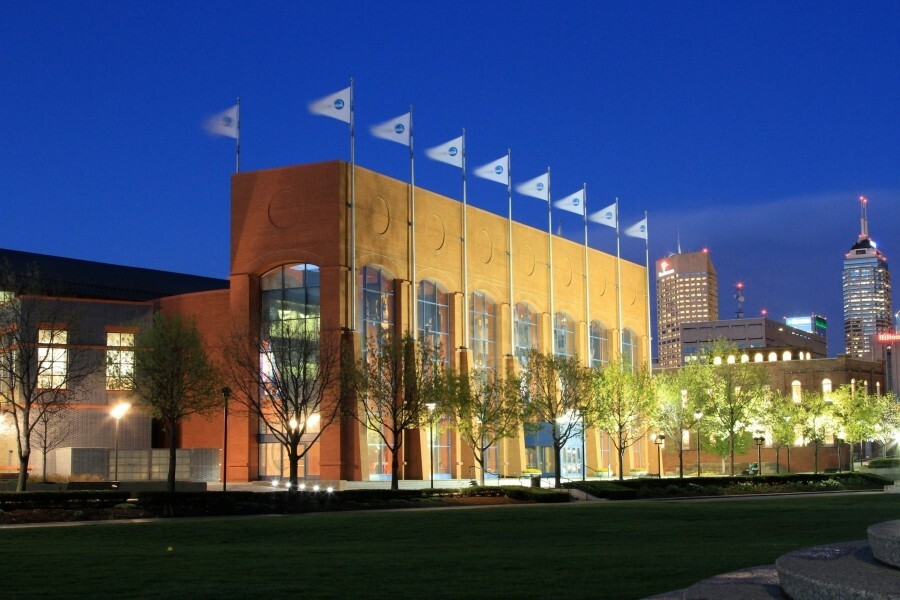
[{"xmin": 843, "ymin": 196, "xmax": 893, "ymax": 358}]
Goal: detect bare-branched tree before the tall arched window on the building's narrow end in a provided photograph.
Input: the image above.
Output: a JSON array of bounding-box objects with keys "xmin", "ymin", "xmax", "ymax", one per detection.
[{"xmin": 225, "ymin": 319, "xmax": 341, "ymax": 493}]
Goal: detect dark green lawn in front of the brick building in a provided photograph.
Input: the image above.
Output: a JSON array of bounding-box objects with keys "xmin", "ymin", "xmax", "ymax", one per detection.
[{"xmin": 7, "ymin": 494, "xmax": 900, "ymax": 599}]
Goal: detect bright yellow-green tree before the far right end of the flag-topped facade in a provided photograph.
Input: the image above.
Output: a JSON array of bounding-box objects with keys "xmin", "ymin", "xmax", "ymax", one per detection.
[{"xmin": 591, "ymin": 361, "xmax": 656, "ymax": 481}]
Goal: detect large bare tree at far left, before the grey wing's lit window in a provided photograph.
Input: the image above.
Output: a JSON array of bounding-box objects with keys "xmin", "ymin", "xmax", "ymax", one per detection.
[{"xmin": 0, "ymin": 264, "xmax": 103, "ymax": 492}]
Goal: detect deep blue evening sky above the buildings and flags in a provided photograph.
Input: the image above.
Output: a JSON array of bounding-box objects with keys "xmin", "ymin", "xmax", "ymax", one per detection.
[{"xmin": 0, "ymin": 1, "xmax": 900, "ymax": 354}]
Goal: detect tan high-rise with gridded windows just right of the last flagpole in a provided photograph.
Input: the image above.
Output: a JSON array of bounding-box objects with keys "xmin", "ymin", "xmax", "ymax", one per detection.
[{"xmin": 656, "ymin": 250, "xmax": 719, "ymax": 367}]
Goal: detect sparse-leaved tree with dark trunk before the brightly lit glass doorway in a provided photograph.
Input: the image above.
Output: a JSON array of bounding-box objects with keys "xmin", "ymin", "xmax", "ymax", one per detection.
[{"xmin": 522, "ymin": 350, "xmax": 593, "ymax": 487}]
